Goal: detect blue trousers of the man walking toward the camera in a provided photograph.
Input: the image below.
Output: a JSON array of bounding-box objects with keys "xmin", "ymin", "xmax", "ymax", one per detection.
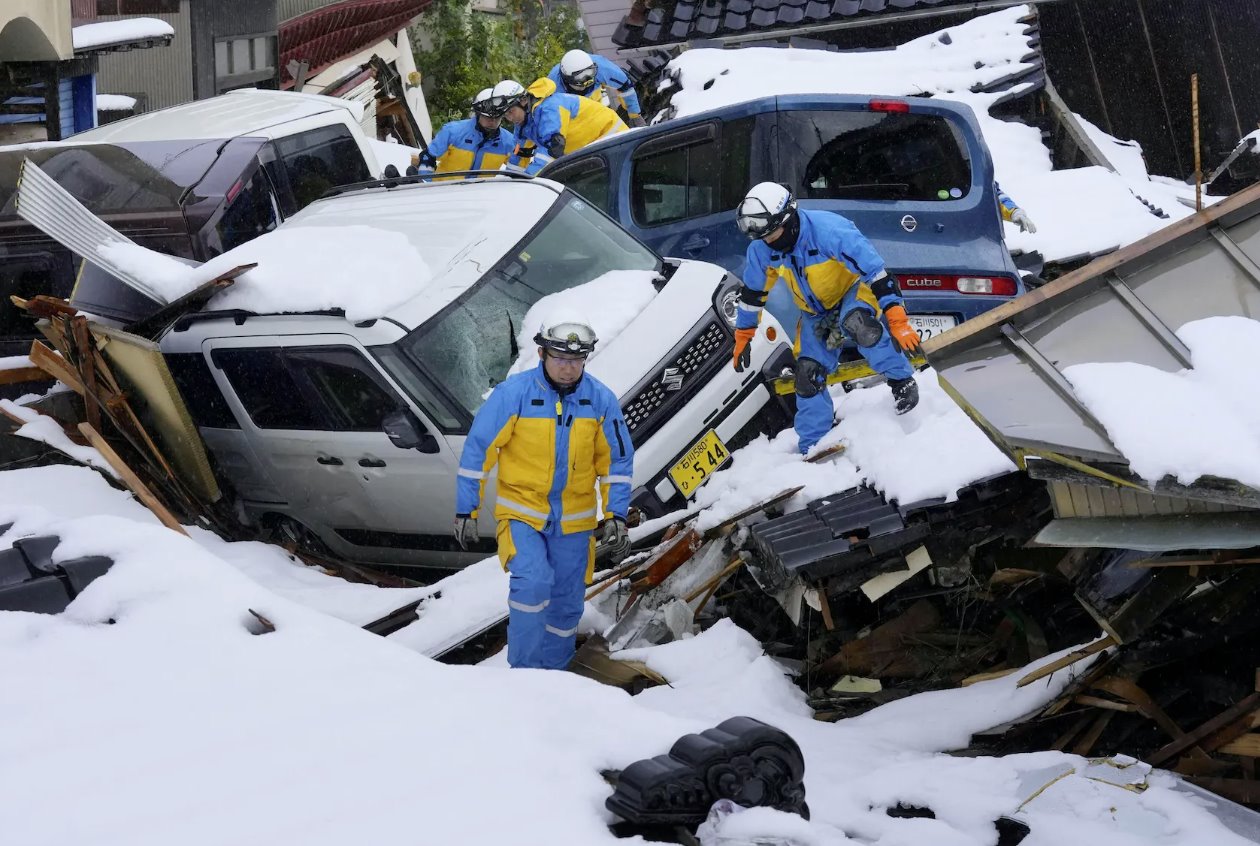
[{"xmin": 496, "ymin": 519, "xmax": 595, "ymax": 669}]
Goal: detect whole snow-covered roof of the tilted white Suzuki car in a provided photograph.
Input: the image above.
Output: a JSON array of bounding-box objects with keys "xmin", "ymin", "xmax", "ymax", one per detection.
[{"xmin": 189, "ymin": 177, "xmax": 564, "ymax": 329}]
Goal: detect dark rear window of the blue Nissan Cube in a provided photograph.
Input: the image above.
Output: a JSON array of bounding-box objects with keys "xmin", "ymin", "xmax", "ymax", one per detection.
[{"xmin": 779, "ymin": 110, "xmax": 971, "ymax": 200}]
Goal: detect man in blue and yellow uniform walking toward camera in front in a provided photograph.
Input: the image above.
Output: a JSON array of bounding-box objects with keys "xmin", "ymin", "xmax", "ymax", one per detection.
[{"xmin": 455, "ymin": 315, "xmax": 634, "ymax": 669}]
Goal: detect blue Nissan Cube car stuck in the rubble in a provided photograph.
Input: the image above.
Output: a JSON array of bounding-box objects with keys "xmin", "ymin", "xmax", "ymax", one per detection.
[{"xmin": 539, "ymin": 95, "xmax": 1024, "ymax": 339}]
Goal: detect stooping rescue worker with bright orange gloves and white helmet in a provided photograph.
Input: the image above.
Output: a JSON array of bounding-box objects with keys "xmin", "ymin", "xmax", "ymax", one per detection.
[{"xmin": 735, "ymin": 182, "xmax": 919, "ymax": 454}]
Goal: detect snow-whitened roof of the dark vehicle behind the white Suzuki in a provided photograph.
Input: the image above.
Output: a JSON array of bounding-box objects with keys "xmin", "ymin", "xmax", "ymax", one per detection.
[{"xmin": 72, "ymin": 88, "xmax": 363, "ymax": 142}]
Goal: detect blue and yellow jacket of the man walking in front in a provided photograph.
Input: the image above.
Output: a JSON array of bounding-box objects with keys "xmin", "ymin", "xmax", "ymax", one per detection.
[{"xmin": 455, "ymin": 362, "xmax": 634, "ymax": 535}]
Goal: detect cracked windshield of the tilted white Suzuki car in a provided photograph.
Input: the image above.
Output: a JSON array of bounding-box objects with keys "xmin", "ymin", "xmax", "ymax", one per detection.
[{"xmin": 399, "ymin": 194, "xmax": 660, "ymax": 415}]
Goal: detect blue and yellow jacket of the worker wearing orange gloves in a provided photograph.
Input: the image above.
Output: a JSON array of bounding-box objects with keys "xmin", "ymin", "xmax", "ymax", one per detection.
[{"xmin": 735, "ymin": 209, "xmax": 905, "ymax": 329}]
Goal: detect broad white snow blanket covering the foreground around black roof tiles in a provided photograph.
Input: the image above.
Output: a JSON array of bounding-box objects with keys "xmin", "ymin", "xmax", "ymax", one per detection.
[{"xmin": 0, "ymin": 466, "xmax": 1249, "ymax": 846}]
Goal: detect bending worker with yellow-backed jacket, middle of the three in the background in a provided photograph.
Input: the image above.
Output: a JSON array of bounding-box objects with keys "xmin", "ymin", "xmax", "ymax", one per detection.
[{"xmin": 491, "ymin": 77, "xmax": 630, "ymax": 173}]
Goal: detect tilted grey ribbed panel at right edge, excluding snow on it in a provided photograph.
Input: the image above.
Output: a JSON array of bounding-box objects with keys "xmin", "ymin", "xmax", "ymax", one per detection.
[{"xmin": 925, "ymin": 185, "xmax": 1260, "ymax": 498}]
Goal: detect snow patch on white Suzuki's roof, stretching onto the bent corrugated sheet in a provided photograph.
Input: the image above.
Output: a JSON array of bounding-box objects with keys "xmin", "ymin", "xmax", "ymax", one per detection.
[{"xmin": 98, "ymin": 226, "xmax": 432, "ymax": 320}]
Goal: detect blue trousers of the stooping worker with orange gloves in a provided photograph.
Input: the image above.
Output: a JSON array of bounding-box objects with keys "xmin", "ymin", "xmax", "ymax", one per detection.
[{"xmin": 793, "ymin": 285, "xmax": 914, "ymax": 455}]
